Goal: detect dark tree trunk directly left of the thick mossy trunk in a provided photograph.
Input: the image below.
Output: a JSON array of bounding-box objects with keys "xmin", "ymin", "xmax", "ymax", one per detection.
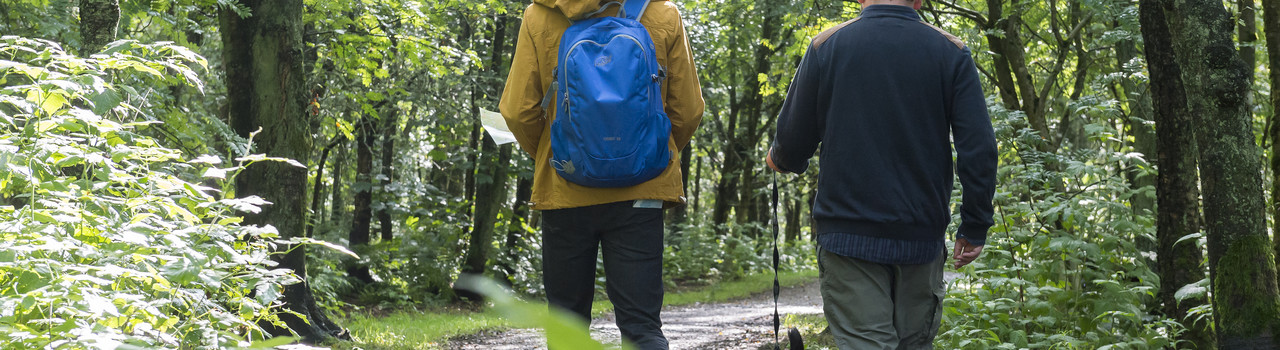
[{"xmin": 1139, "ymin": 0, "xmax": 1215, "ymax": 349}]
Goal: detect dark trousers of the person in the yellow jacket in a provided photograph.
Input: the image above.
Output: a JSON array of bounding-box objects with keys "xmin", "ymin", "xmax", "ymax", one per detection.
[{"xmin": 543, "ymin": 201, "xmax": 667, "ymax": 350}]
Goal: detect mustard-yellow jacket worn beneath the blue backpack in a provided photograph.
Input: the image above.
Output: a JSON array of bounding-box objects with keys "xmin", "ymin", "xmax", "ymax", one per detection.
[{"xmin": 499, "ymin": 0, "xmax": 703, "ymax": 210}]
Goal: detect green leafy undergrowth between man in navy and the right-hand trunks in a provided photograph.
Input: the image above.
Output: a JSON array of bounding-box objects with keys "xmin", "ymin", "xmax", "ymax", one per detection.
[{"xmin": 934, "ymin": 108, "xmax": 1183, "ymax": 349}]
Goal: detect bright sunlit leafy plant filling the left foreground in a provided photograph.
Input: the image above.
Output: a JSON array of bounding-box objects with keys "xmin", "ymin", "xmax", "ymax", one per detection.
[{"xmin": 0, "ymin": 36, "xmax": 297, "ymax": 349}]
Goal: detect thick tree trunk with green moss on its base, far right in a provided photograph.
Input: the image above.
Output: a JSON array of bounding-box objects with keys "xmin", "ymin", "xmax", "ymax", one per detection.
[{"xmin": 1164, "ymin": 0, "xmax": 1280, "ymax": 349}]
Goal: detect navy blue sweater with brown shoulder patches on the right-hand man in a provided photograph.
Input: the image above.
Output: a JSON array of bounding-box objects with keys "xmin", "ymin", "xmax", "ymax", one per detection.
[{"xmin": 772, "ymin": 5, "xmax": 997, "ymax": 244}]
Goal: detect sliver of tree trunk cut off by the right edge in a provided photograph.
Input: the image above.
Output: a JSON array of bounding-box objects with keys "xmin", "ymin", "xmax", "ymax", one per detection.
[{"xmin": 1262, "ymin": 0, "xmax": 1280, "ymax": 288}]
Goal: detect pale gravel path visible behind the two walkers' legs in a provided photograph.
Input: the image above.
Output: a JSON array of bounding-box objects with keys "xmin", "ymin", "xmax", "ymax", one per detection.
[{"xmin": 445, "ymin": 282, "xmax": 822, "ymax": 350}]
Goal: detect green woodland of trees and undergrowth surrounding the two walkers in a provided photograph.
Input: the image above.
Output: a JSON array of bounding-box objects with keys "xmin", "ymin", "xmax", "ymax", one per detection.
[{"xmin": 0, "ymin": 0, "xmax": 1280, "ymax": 349}]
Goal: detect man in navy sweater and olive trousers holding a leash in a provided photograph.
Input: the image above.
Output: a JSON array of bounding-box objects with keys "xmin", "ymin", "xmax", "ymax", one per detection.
[{"xmin": 765, "ymin": 0, "xmax": 997, "ymax": 350}]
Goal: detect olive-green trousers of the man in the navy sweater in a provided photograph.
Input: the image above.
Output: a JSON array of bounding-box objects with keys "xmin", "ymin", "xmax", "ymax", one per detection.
[{"xmin": 818, "ymin": 247, "xmax": 946, "ymax": 350}]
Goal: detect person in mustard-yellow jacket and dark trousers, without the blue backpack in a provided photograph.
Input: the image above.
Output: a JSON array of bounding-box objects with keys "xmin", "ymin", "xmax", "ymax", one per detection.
[{"xmin": 499, "ymin": 0, "xmax": 704, "ymax": 349}]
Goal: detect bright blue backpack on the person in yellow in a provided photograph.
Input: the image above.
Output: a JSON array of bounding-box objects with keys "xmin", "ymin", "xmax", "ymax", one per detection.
[{"xmin": 543, "ymin": 0, "xmax": 671, "ymax": 187}]
